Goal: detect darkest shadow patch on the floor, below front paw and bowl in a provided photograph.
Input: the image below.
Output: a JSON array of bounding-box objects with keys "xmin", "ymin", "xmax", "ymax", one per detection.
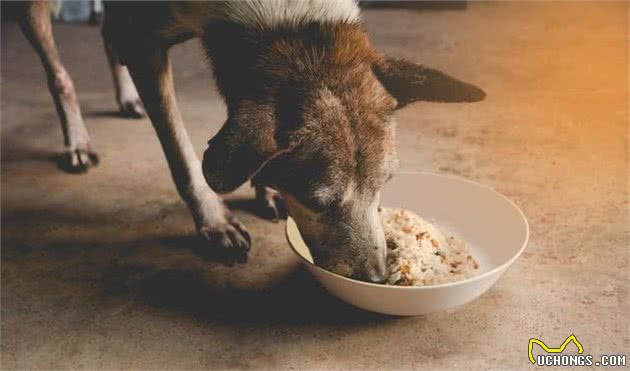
[{"xmin": 106, "ymin": 260, "xmax": 389, "ymax": 325}]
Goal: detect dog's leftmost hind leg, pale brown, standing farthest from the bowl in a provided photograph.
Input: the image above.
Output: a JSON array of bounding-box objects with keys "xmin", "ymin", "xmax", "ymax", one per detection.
[{"xmin": 19, "ymin": 1, "xmax": 98, "ymax": 172}]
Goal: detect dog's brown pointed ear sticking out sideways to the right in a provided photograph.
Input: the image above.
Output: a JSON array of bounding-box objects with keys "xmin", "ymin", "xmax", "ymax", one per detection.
[{"xmin": 373, "ymin": 57, "xmax": 486, "ymax": 108}]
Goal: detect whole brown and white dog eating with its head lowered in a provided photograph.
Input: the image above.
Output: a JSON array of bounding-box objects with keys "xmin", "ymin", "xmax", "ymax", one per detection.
[{"xmin": 20, "ymin": 0, "xmax": 485, "ymax": 282}]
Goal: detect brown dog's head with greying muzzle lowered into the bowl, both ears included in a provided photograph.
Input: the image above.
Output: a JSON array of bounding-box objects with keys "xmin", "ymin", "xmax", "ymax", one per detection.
[{"xmin": 203, "ymin": 22, "xmax": 485, "ymax": 282}]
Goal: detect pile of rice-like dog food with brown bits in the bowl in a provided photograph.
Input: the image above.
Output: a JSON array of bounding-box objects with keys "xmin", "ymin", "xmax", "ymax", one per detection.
[{"xmin": 380, "ymin": 208, "xmax": 479, "ymax": 286}]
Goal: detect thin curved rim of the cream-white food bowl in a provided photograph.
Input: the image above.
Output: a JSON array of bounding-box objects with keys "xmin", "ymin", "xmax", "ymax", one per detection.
[{"xmin": 284, "ymin": 171, "xmax": 530, "ymax": 290}]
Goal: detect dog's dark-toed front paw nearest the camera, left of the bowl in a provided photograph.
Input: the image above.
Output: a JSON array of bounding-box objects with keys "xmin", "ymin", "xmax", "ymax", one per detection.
[{"xmin": 197, "ymin": 216, "xmax": 252, "ymax": 266}]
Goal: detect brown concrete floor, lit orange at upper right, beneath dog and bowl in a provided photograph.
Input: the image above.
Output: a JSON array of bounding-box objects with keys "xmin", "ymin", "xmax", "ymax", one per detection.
[{"xmin": 1, "ymin": 2, "xmax": 630, "ymax": 369}]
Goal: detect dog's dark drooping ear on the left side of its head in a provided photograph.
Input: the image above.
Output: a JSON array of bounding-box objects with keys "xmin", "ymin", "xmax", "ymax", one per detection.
[{"xmin": 203, "ymin": 101, "xmax": 289, "ymax": 193}]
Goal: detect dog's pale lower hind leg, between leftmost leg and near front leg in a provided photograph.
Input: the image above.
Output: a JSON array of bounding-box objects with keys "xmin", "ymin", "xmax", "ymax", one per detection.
[{"xmin": 105, "ymin": 41, "xmax": 144, "ymax": 118}]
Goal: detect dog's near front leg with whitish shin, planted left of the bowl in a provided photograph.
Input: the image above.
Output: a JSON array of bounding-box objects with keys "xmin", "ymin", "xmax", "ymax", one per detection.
[{"xmin": 127, "ymin": 47, "xmax": 251, "ymax": 264}]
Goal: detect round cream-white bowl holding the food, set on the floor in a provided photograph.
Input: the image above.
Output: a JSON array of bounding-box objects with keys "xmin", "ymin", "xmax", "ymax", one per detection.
[{"xmin": 286, "ymin": 173, "xmax": 529, "ymax": 316}]
